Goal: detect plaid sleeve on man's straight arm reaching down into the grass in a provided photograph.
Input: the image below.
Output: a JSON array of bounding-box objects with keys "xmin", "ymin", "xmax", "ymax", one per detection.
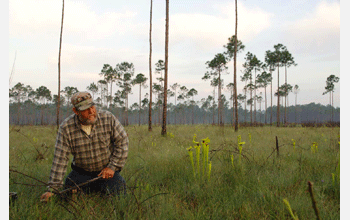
[{"xmin": 49, "ymin": 128, "xmax": 70, "ymax": 190}]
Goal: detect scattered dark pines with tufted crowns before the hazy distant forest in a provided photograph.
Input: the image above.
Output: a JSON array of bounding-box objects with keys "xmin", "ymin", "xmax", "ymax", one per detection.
[{"xmin": 9, "ymin": 40, "xmax": 339, "ymax": 126}]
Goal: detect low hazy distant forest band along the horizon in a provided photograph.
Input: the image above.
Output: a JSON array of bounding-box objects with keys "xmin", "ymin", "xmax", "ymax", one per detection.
[{"xmin": 9, "ymin": 83, "xmax": 340, "ymax": 125}]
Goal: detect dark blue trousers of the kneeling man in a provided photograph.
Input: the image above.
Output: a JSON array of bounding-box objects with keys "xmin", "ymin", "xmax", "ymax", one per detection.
[{"xmin": 64, "ymin": 165, "xmax": 126, "ymax": 195}]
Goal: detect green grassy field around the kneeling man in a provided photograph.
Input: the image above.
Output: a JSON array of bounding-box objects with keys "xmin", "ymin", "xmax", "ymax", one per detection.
[{"xmin": 9, "ymin": 125, "xmax": 340, "ymax": 219}]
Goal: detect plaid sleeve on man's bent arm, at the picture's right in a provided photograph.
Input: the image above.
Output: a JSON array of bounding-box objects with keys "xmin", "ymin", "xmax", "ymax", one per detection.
[{"xmin": 107, "ymin": 115, "xmax": 129, "ymax": 171}]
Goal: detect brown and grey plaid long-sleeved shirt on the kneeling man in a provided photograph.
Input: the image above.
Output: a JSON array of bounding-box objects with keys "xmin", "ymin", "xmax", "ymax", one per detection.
[{"xmin": 49, "ymin": 111, "xmax": 129, "ymax": 189}]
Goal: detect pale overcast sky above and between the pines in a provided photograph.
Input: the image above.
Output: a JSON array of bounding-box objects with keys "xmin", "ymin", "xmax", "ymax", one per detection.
[{"xmin": 6, "ymin": 0, "xmax": 343, "ymax": 106}]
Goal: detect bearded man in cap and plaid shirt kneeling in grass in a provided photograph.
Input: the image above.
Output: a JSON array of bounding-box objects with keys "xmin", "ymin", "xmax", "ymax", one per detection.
[{"xmin": 41, "ymin": 92, "xmax": 129, "ymax": 201}]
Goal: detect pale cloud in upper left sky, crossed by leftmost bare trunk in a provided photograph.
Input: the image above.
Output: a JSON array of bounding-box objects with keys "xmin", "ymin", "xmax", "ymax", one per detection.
[{"xmin": 9, "ymin": 0, "xmax": 137, "ymax": 40}]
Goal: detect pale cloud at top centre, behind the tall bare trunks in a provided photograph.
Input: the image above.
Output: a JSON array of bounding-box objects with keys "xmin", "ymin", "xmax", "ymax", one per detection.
[{"xmin": 150, "ymin": 3, "xmax": 273, "ymax": 51}]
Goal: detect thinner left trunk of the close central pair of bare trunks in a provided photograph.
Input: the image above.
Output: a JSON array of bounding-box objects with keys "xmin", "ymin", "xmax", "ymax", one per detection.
[{"xmin": 148, "ymin": 0, "xmax": 153, "ymax": 131}]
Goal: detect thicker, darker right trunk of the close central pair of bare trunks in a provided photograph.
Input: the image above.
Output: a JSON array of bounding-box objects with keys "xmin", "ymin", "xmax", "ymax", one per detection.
[{"xmin": 161, "ymin": 0, "xmax": 169, "ymax": 135}]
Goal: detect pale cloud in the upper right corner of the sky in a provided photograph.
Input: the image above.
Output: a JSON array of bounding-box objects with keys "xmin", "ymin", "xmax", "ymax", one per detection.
[{"xmin": 284, "ymin": 1, "xmax": 340, "ymax": 56}]
